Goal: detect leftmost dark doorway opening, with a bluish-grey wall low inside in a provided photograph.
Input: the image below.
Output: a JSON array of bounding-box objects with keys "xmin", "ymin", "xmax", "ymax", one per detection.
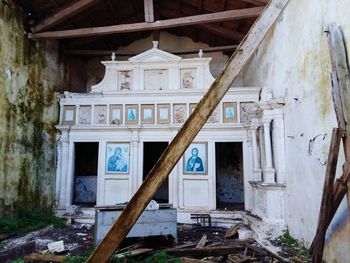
[{"xmin": 73, "ymin": 142, "xmax": 98, "ymax": 207}]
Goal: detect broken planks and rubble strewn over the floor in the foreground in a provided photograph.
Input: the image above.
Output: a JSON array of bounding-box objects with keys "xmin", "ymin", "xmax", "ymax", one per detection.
[{"xmin": 0, "ymin": 224, "xmax": 307, "ymax": 263}]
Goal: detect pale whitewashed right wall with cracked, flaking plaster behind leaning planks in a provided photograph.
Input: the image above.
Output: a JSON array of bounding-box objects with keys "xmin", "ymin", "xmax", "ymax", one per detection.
[{"xmin": 243, "ymin": 0, "xmax": 350, "ymax": 262}]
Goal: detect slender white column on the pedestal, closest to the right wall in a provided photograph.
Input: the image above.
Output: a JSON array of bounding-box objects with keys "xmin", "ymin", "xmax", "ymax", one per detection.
[{"xmin": 262, "ymin": 118, "xmax": 276, "ymax": 183}]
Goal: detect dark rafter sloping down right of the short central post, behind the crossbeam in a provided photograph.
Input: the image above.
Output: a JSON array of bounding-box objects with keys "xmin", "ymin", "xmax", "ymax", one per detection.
[{"xmin": 159, "ymin": 7, "xmax": 245, "ymax": 42}]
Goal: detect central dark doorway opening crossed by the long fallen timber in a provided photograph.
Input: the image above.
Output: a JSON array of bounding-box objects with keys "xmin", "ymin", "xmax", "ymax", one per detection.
[{"xmin": 143, "ymin": 142, "xmax": 169, "ymax": 203}]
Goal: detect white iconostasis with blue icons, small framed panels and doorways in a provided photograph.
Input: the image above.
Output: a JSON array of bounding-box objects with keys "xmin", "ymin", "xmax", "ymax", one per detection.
[{"xmin": 56, "ymin": 43, "xmax": 260, "ymax": 219}]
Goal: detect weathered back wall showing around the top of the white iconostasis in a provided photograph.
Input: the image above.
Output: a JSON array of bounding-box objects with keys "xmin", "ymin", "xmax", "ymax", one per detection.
[{"xmin": 87, "ymin": 32, "xmax": 228, "ymax": 91}]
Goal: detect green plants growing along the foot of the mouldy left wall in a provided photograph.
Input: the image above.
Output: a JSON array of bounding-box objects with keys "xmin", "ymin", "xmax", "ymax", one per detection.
[{"xmin": 0, "ymin": 209, "xmax": 67, "ymax": 235}]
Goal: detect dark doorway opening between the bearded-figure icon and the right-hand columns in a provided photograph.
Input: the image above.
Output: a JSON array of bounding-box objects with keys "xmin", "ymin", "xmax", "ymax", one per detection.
[{"xmin": 215, "ymin": 142, "xmax": 244, "ymax": 210}]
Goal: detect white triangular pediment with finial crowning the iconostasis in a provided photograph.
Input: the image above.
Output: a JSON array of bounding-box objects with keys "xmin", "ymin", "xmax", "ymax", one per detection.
[{"xmin": 129, "ymin": 41, "xmax": 181, "ymax": 62}]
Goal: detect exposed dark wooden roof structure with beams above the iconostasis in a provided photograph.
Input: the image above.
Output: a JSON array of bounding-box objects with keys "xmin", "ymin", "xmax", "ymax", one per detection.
[{"xmin": 17, "ymin": 0, "xmax": 268, "ymax": 55}]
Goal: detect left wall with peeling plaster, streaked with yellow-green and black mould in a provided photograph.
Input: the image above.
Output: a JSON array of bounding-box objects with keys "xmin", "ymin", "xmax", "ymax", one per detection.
[{"xmin": 0, "ymin": 3, "xmax": 63, "ymax": 214}]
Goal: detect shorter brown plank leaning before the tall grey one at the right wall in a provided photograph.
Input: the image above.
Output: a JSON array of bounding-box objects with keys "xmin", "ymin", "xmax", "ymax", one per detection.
[{"xmin": 311, "ymin": 128, "xmax": 343, "ymax": 262}]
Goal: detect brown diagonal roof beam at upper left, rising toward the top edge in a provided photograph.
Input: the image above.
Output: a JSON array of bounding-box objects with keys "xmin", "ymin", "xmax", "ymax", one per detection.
[{"xmin": 31, "ymin": 0, "xmax": 100, "ymax": 33}]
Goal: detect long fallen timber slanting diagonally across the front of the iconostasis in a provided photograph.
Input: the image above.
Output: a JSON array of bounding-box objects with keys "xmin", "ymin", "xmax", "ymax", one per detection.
[{"xmin": 87, "ymin": 0, "xmax": 289, "ymax": 263}]
